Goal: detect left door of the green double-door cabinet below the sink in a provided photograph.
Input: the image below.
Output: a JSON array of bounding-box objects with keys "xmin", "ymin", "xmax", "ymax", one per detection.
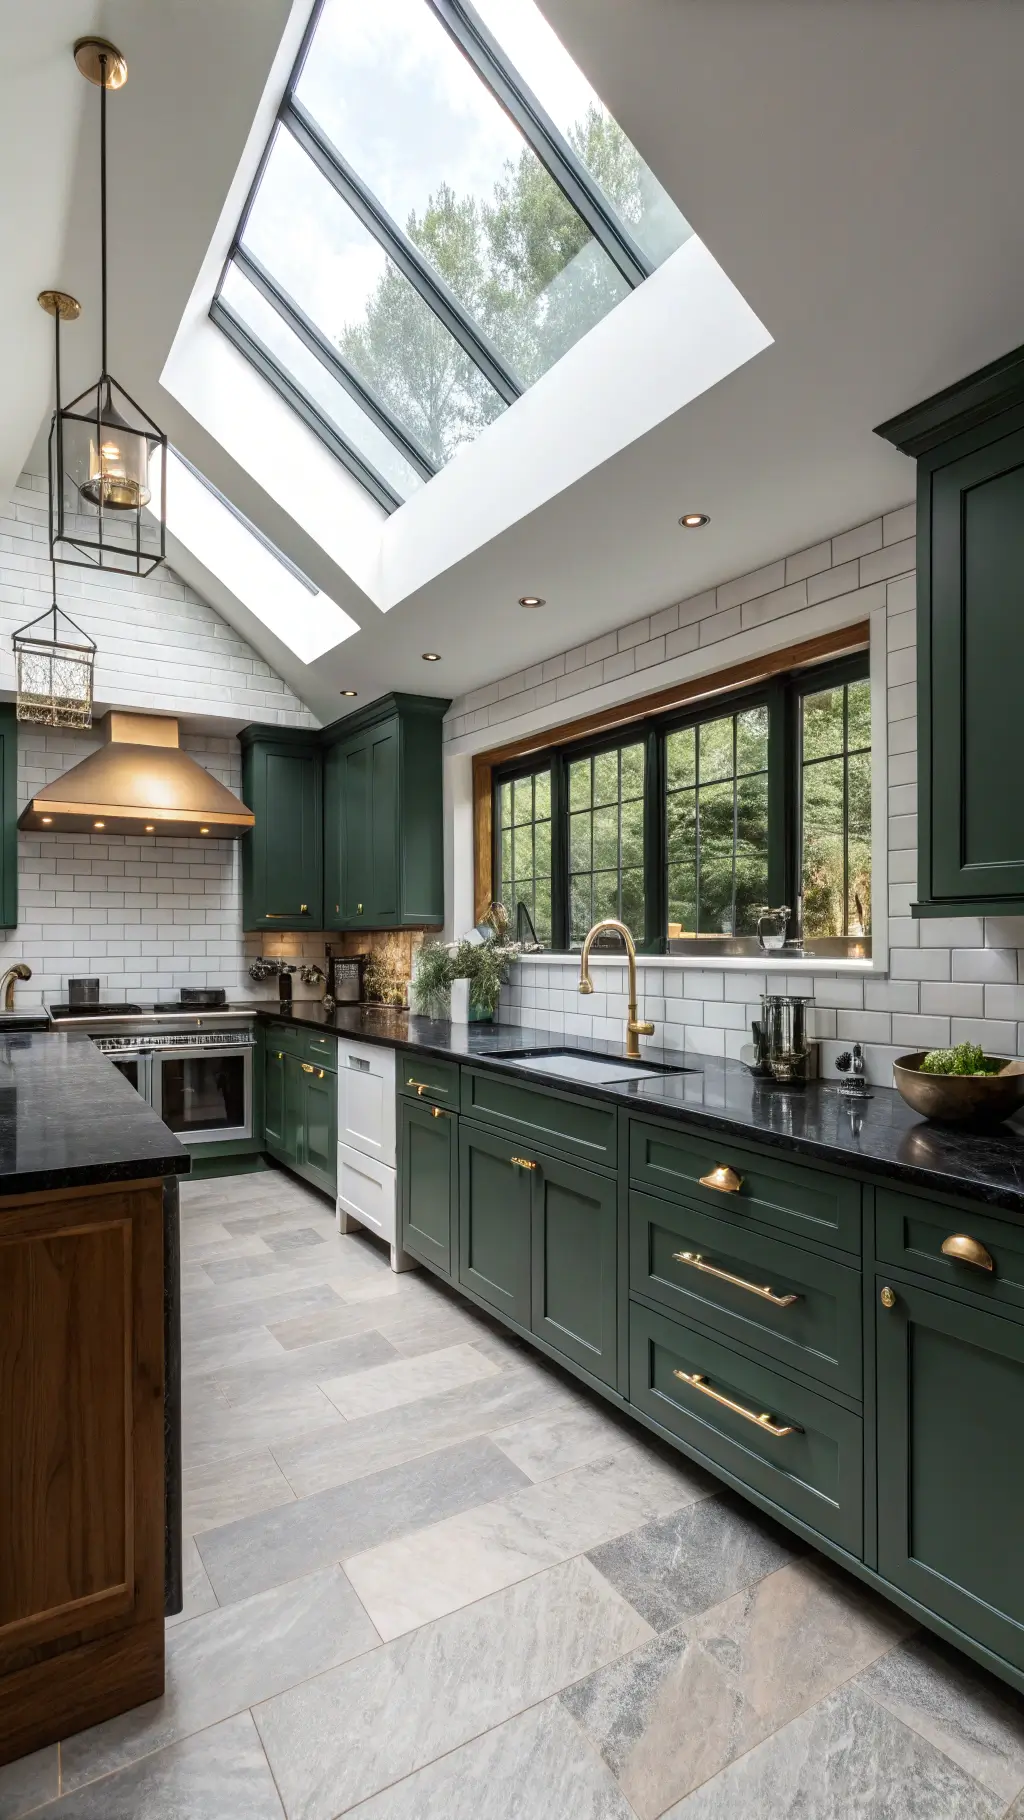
[{"xmin": 458, "ymin": 1119, "xmax": 537, "ymax": 1327}]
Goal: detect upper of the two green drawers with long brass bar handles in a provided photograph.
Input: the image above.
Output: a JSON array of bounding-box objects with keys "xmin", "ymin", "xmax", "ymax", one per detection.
[{"xmin": 629, "ymin": 1190, "xmax": 862, "ymax": 1396}]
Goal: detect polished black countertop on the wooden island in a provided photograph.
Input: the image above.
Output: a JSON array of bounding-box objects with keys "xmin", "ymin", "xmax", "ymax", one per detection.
[{"xmin": 0, "ymin": 1030, "xmax": 191, "ymax": 1194}]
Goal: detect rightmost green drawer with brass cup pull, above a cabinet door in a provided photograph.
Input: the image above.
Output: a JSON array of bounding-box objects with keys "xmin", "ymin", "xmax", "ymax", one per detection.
[{"xmin": 875, "ymin": 1188, "xmax": 1024, "ymax": 1320}]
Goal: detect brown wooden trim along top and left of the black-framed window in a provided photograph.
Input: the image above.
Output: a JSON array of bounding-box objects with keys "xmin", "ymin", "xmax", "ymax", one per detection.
[{"xmin": 473, "ymin": 621, "xmax": 869, "ymax": 921}]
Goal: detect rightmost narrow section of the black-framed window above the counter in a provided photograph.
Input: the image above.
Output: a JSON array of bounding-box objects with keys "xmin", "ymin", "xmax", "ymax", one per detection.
[{"xmin": 800, "ymin": 677, "xmax": 871, "ymax": 937}]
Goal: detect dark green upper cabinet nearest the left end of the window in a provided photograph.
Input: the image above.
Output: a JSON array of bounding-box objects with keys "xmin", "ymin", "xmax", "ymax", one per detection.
[{"xmin": 320, "ymin": 695, "xmax": 447, "ymax": 928}]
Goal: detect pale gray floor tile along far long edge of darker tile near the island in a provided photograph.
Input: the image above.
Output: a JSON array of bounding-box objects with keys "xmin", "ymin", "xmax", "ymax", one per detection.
[{"xmin": 275, "ymin": 1372, "xmax": 575, "ymax": 1498}]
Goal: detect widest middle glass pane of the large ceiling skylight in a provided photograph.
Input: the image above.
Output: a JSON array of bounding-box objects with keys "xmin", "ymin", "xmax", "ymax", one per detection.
[{"xmin": 296, "ymin": 0, "xmax": 631, "ymax": 386}]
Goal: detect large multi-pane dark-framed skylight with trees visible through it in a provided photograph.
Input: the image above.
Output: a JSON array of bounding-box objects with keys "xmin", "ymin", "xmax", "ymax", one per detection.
[{"xmin": 211, "ymin": 0, "xmax": 691, "ymax": 510}]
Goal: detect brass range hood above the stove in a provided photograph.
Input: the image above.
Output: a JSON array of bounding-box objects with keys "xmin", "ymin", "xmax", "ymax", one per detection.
[{"xmin": 18, "ymin": 708, "xmax": 256, "ymax": 841}]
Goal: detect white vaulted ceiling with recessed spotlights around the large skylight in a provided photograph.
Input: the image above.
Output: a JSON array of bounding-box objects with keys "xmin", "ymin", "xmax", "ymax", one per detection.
[{"xmin": 0, "ymin": 0, "xmax": 1024, "ymax": 717}]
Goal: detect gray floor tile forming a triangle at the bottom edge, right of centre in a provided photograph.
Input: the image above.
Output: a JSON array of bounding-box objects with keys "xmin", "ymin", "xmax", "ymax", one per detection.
[{"xmin": 664, "ymin": 1687, "xmax": 1002, "ymax": 1820}]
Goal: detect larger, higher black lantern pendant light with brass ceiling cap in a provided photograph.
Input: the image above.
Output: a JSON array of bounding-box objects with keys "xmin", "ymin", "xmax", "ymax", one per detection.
[{"xmin": 49, "ymin": 38, "xmax": 167, "ymax": 575}]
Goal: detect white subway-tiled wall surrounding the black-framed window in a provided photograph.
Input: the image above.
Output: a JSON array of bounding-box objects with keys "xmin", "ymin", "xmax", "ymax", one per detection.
[{"xmin": 446, "ymin": 506, "xmax": 1024, "ymax": 1083}]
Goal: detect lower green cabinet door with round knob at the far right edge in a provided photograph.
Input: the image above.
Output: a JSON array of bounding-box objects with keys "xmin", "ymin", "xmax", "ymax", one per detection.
[{"xmin": 877, "ymin": 1276, "xmax": 1024, "ymax": 1669}]
